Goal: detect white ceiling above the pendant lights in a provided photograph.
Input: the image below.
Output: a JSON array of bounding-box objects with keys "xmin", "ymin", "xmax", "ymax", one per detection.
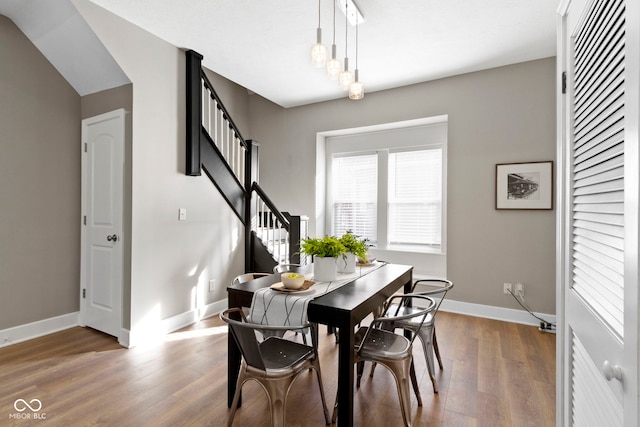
[{"xmin": 0, "ymin": 0, "xmax": 559, "ymax": 107}]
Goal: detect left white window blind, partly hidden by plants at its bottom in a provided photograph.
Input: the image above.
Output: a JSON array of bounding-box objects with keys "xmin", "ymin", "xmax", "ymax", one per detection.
[{"xmin": 332, "ymin": 154, "xmax": 378, "ymax": 244}]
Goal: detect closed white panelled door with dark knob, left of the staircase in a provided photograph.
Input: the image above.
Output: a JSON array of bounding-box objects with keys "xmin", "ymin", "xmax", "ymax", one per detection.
[{"xmin": 80, "ymin": 109, "xmax": 125, "ymax": 337}]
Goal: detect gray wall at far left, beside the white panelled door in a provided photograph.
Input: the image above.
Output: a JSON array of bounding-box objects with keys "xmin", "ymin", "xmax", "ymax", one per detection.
[{"xmin": 0, "ymin": 15, "xmax": 80, "ymax": 329}]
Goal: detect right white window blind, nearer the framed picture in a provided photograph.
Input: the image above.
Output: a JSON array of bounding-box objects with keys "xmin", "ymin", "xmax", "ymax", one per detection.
[{"xmin": 388, "ymin": 148, "xmax": 442, "ymax": 246}]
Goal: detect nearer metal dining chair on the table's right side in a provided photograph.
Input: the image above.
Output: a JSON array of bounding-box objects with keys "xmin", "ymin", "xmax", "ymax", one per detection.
[{"xmin": 332, "ymin": 294, "xmax": 436, "ymax": 426}]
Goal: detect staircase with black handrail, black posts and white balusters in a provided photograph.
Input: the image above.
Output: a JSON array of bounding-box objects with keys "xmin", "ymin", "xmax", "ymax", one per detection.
[{"xmin": 185, "ymin": 50, "xmax": 309, "ymax": 272}]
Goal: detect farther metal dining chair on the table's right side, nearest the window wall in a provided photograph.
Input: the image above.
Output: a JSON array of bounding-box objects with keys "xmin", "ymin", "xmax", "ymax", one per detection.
[{"xmin": 369, "ymin": 279, "xmax": 453, "ymax": 393}]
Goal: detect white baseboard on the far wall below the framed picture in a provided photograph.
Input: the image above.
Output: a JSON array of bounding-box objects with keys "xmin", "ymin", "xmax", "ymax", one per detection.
[{"xmin": 440, "ymin": 299, "xmax": 556, "ymax": 326}]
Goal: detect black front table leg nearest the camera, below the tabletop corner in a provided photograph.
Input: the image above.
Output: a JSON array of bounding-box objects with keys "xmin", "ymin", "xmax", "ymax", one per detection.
[{"xmin": 338, "ymin": 325, "xmax": 355, "ymax": 426}]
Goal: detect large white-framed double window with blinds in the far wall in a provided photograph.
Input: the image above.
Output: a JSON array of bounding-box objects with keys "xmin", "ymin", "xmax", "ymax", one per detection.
[{"xmin": 326, "ymin": 123, "xmax": 446, "ymax": 253}]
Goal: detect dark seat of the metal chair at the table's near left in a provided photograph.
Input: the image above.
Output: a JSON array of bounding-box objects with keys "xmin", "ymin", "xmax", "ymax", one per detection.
[{"xmin": 259, "ymin": 337, "xmax": 314, "ymax": 375}]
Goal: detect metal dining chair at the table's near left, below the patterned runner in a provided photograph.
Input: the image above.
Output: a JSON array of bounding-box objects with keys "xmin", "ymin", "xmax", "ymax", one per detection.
[{"xmin": 220, "ymin": 308, "xmax": 330, "ymax": 427}]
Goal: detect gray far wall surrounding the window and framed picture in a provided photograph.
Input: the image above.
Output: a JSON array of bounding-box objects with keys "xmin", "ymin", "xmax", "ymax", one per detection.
[{"xmin": 250, "ymin": 58, "xmax": 556, "ymax": 314}]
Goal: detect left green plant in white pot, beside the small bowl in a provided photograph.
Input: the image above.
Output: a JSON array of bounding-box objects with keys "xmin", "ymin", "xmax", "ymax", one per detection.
[{"xmin": 300, "ymin": 236, "xmax": 347, "ymax": 282}]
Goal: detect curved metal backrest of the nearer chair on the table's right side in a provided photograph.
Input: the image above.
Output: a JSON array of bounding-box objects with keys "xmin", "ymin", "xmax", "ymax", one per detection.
[{"xmin": 356, "ymin": 294, "xmax": 436, "ymax": 351}]
